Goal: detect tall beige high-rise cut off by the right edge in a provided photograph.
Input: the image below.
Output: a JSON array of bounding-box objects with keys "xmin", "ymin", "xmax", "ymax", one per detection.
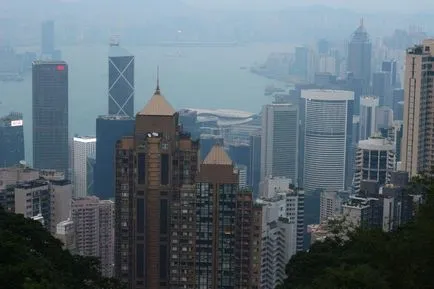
[{"xmin": 401, "ymin": 39, "xmax": 434, "ymax": 176}]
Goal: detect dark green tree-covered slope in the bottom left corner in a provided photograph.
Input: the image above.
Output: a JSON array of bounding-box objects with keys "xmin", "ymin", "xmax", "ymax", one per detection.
[{"xmin": 0, "ymin": 207, "xmax": 123, "ymax": 289}]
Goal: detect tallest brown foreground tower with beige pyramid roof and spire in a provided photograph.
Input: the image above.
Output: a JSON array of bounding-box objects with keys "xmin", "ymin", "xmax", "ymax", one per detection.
[{"xmin": 113, "ymin": 85, "xmax": 199, "ymax": 289}]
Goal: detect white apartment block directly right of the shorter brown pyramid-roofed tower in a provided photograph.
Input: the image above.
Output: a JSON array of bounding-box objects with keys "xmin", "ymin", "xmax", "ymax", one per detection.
[{"xmin": 257, "ymin": 177, "xmax": 304, "ymax": 289}]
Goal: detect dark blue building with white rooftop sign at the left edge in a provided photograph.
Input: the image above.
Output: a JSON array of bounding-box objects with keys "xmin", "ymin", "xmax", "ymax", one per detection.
[{"xmin": 0, "ymin": 113, "xmax": 24, "ymax": 167}]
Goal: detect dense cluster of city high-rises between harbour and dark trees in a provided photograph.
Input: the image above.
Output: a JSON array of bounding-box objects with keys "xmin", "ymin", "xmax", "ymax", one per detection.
[{"xmin": 0, "ymin": 17, "xmax": 434, "ymax": 289}]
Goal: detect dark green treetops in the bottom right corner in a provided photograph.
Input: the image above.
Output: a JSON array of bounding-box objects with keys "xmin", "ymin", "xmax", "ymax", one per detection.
[{"xmin": 278, "ymin": 173, "xmax": 434, "ymax": 289}]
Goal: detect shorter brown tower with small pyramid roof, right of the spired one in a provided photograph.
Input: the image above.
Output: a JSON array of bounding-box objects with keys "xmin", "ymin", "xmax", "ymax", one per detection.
[{"xmin": 195, "ymin": 145, "xmax": 260, "ymax": 289}]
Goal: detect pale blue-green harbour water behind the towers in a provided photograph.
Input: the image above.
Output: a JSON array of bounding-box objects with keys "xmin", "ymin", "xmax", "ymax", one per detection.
[{"xmin": 0, "ymin": 44, "xmax": 292, "ymax": 163}]
